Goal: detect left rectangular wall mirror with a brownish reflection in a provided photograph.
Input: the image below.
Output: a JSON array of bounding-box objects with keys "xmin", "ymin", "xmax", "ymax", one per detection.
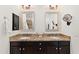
[{"xmin": 23, "ymin": 12, "xmax": 35, "ymax": 31}]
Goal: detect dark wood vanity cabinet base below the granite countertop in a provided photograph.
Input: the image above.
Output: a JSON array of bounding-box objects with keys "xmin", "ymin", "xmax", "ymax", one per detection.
[{"xmin": 10, "ymin": 41, "xmax": 70, "ymax": 54}]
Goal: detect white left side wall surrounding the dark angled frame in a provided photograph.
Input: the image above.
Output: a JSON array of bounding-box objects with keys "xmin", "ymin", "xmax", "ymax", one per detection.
[{"xmin": 0, "ymin": 5, "xmax": 19, "ymax": 54}]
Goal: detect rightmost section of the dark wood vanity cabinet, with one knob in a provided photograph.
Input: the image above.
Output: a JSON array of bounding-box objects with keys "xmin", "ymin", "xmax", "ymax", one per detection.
[{"xmin": 59, "ymin": 41, "xmax": 70, "ymax": 54}]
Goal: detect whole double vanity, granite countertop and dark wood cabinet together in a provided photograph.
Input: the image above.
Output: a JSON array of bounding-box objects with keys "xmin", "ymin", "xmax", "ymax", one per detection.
[{"xmin": 10, "ymin": 34, "xmax": 71, "ymax": 54}]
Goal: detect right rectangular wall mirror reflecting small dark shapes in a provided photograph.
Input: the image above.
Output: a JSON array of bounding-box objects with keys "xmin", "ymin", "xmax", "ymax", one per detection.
[{"xmin": 45, "ymin": 12, "xmax": 59, "ymax": 32}]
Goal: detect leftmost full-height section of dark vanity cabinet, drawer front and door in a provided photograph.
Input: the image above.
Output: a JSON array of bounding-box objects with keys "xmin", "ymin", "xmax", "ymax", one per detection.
[{"xmin": 10, "ymin": 41, "xmax": 22, "ymax": 54}]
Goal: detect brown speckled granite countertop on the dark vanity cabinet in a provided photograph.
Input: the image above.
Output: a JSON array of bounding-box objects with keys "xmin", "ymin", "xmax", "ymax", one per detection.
[{"xmin": 10, "ymin": 33, "xmax": 71, "ymax": 41}]
